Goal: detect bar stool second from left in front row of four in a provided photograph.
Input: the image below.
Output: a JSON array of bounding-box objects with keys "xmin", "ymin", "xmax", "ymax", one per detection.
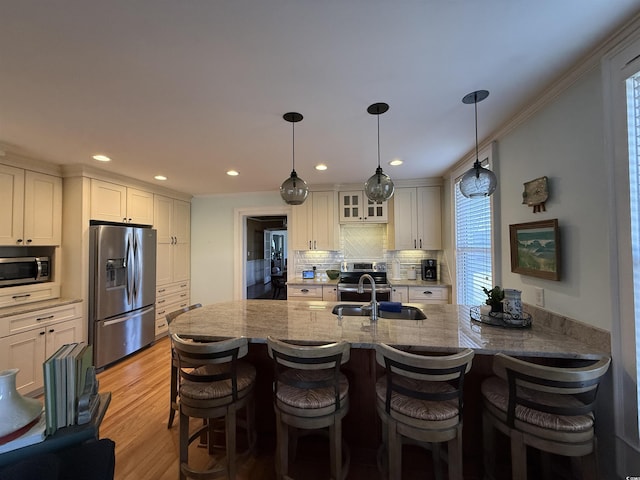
[{"xmin": 267, "ymin": 337, "xmax": 350, "ymax": 480}]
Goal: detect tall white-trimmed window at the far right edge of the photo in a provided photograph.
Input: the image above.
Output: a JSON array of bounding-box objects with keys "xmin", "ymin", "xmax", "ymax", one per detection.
[{"xmin": 602, "ymin": 34, "xmax": 640, "ymax": 468}]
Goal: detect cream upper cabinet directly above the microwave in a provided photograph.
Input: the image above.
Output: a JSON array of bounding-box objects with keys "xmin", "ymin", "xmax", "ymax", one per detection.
[{"xmin": 0, "ymin": 165, "xmax": 62, "ymax": 246}]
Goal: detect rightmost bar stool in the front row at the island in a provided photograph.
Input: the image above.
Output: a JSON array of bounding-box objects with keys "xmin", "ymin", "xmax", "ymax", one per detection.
[{"xmin": 482, "ymin": 353, "xmax": 611, "ymax": 480}]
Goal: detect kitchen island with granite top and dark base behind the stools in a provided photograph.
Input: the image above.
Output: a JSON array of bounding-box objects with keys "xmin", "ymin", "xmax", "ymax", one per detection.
[{"xmin": 169, "ymin": 300, "xmax": 610, "ymax": 478}]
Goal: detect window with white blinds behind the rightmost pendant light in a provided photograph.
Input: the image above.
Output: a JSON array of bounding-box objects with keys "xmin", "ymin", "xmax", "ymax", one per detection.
[{"xmin": 453, "ymin": 145, "xmax": 493, "ymax": 305}]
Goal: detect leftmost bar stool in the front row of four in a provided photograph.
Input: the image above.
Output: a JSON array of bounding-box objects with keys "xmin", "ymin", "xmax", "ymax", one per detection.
[{"xmin": 171, "ymin": 335, "xmax": 256, "ymax": 480}]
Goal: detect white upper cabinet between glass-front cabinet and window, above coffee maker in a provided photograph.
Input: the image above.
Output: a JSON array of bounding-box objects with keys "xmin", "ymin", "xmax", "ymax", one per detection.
[{"xmin": 389, "ymin": 187, "xmax": 442, "ymax": 250}]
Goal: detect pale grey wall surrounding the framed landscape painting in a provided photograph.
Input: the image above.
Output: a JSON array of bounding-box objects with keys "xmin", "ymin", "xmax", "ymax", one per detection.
[{"xmin": 497, "ymin": 69, "xmax": 612, "ymax": 331}]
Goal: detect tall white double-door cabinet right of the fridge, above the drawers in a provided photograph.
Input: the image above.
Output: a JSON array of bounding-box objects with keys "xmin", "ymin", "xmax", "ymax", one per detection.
[{"xmin": 153, "ymin": 195, "xmax": 191, "ymax": 285}]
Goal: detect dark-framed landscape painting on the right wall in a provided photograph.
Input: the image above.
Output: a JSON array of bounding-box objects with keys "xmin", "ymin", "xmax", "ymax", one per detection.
[{"xmin": 509, "ymin": 218, "xmax": 560, "ymax": 280}]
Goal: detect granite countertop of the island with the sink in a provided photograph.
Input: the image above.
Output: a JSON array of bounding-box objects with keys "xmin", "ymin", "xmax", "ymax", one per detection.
[{"xmin": 169, "ymin": 300, "xmax": 608, "ymax": 358}]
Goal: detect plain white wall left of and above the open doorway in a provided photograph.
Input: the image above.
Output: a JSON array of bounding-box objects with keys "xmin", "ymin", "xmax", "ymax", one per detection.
[{"xmin": 191, "ymin": 191, "xmax": 284, "ymax": 305}]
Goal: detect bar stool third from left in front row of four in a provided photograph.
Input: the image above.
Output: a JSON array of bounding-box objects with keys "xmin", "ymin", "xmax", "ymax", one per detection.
[{"xmin": 376, "ymin": 344, "xmax": 473, "ymax": 480}]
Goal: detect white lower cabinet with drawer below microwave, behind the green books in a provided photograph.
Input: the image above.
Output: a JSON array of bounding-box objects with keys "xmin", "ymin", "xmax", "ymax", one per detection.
[{"xmin": 0, "ymin": 303, "xmax": 85, "ymax": 395}]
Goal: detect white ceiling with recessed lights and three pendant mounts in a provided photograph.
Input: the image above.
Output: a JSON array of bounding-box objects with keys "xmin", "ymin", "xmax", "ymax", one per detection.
[{"xmin": 0, "ymin": 0, "xmax": 640, "ymax": 195}]
